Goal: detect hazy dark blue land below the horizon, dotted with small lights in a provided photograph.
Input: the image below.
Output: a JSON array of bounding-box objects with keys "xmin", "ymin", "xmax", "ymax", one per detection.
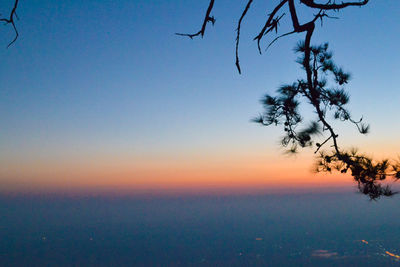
[{"xmin": 0, "ymin": 192, "xmax": 400, "ymax": 266}]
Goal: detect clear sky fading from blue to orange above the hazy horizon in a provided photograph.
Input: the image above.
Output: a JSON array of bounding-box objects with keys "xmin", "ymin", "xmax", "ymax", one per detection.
[{"xmin": 0, "ymin": 0, "xmax": 400, "ymax": 197}]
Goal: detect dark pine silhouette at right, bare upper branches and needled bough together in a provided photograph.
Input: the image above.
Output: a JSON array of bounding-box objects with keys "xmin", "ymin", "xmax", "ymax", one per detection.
[{"xmin": 177, "ymin": 0, "xmax": 400, "ymax": 200}]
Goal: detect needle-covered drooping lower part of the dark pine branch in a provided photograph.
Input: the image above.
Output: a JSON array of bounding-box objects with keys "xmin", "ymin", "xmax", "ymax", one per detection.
[{"xmin": 254, "ymin": 42, "xmax": 400, "ymax": 199}]
